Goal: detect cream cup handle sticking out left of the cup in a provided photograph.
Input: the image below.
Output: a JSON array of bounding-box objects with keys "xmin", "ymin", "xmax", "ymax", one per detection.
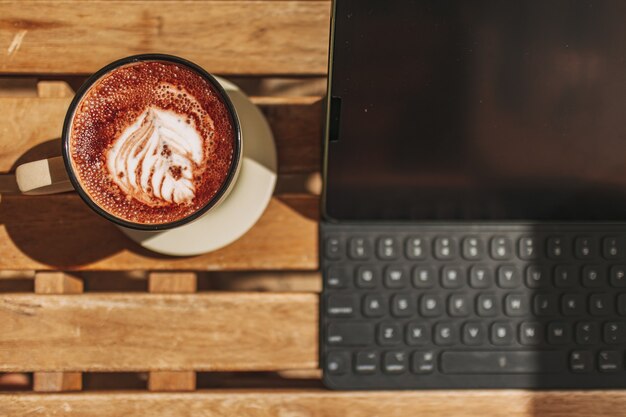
[{"xmin": 15, "ymin": 156, "xmax": 74, "ymax": 195}]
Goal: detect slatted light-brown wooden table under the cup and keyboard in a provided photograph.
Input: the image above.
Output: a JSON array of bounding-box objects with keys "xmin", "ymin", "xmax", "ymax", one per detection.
[{"xmin": 0, "ymin": 0, "xmax": 626, "ymax": 417}]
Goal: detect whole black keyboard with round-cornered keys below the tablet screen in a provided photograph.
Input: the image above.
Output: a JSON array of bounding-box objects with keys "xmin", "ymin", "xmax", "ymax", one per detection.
[{"xmin": 320, "ymin": 223, "xmax": 626, "ymax": 389}]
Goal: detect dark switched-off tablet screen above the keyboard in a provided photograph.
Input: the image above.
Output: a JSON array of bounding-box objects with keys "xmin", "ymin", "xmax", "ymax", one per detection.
[{"xmin": 324, "ymin": 0, "xmax": 626, "ymax": 221}]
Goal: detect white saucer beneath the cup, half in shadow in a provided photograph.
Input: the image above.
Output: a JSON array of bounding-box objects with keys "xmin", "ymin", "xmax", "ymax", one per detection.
[{"xmin": 120, "ymin": 78, "xmax": 276, "ymax": 256}]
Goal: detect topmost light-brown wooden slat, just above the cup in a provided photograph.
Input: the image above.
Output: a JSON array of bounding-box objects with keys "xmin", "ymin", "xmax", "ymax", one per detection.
[{"xmin": 0, "ymin": 0, "xmax": 330, "ymax": 74}]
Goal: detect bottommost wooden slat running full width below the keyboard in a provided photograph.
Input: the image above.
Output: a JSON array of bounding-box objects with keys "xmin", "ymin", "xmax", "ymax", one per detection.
[{"xmin": 0, "ymin": 390, "xmax": 626, "ymax": 417}]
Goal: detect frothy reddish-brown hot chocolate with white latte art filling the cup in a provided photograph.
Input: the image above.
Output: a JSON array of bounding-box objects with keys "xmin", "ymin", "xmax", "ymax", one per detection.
[{"xmin": 68, "ymin": 61, "xmax": 236, "ymax": 225}]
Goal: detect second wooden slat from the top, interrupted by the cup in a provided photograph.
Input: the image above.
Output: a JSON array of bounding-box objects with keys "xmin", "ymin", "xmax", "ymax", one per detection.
[{"xmin": 0, "ymin": 94, "xmax": 322, "ymax": 173}]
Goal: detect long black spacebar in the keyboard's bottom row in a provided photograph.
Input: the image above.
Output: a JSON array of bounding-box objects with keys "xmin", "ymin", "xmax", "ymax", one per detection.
[{"xmin": 441, "ymin": 351, "xmax": 567, "ymax": 374}]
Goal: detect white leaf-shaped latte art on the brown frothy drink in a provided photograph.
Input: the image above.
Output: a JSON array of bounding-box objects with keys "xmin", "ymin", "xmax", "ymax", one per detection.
[{"xmin": 107, "ymin": 102, "xmax": 203, "ymax": 206}]
